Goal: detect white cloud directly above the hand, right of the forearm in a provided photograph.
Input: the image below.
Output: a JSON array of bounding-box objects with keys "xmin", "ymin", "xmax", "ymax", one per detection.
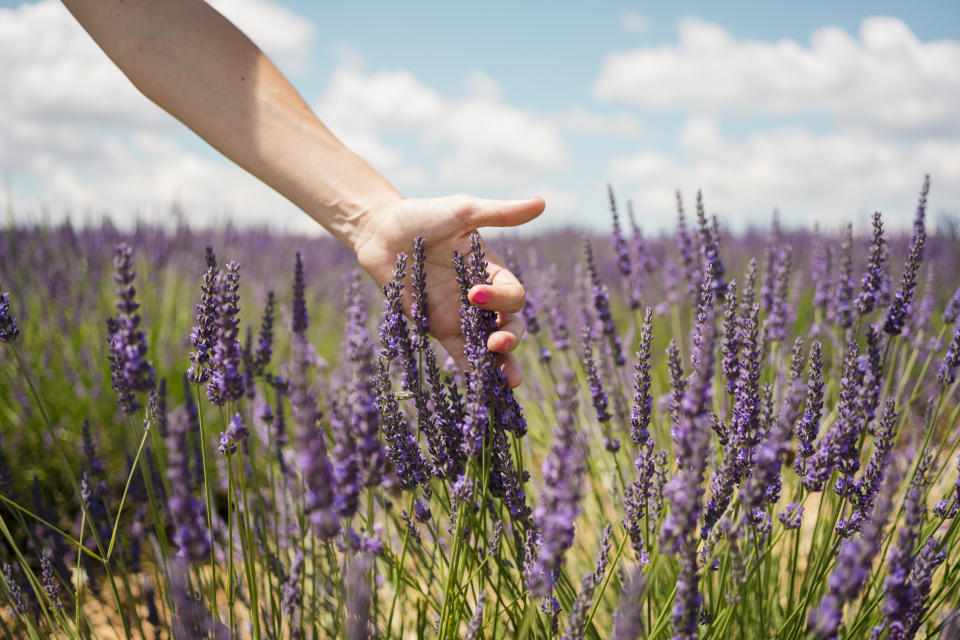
[{"xmin": 316, "ymin": 62, "xmax": 569, "ymax": 190}]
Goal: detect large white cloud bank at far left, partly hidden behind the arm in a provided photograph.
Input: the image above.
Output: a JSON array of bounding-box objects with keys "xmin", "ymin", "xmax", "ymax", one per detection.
[{"xmin": 0, "ymin": 0, "xmax": 313, "ymax": 226}]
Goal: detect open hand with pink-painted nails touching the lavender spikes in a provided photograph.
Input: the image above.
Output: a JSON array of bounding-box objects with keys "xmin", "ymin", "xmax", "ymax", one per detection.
[{"xmin": 354, "ymin": 195, "xmax": 545, "ymax": 388}]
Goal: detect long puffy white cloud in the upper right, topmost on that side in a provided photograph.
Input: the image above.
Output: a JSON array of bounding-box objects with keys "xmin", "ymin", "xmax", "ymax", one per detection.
[{"xmin": 594, "ymin": 17, "xmax": 960, "ymax": 133}]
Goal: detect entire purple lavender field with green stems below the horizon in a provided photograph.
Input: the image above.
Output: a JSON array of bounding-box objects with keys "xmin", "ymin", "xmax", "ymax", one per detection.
[{"xmin": 0, "ymin": 176, "xmax": 960, "ymax": 640}]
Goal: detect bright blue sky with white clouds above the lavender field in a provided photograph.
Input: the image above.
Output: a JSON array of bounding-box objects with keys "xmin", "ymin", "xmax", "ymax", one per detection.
[{"xmin": 0, "ymin": 0, "xmax": 960, "ymax": 233}]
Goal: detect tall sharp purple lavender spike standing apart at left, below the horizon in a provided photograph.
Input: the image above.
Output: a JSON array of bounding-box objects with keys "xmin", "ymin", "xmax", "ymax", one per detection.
[{"xmin": 110, "ymin": 244, "xmax": 157, "ymax": 402}]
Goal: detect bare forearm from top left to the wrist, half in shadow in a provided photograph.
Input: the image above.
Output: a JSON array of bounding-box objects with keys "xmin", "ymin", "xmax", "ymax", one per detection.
[{"xmin": 64, "ymin": 0, "xmax": 400, "ymax": 250}]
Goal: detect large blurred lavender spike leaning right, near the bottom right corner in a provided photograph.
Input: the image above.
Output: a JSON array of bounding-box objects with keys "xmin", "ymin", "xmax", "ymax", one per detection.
[{"xmin": 807, "ymin": 470, "xmax": 897, "ymax": 640}]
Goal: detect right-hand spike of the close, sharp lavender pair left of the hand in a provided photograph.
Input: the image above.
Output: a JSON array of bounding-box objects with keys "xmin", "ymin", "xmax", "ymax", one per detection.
[{"xmin": 207, "ymin": 262, "xmax": 246, "ymax": 406}]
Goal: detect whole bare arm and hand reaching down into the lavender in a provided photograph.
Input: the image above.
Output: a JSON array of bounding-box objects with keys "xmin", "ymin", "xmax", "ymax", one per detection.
[{"xmin": 63, "ymin": 0, "xmax": 545, "ymax": 387}]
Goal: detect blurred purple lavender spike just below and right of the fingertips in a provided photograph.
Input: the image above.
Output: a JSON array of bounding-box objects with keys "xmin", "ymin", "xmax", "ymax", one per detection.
[{"xmin": 527, "ymin": 372, "xmax": 587, "ymax": 598}]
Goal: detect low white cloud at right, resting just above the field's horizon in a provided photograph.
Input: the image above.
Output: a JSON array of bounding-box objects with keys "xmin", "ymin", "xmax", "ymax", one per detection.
[{"xmin": 610, "ymin": 118, "xmax": 960, "ymax": 229}]
